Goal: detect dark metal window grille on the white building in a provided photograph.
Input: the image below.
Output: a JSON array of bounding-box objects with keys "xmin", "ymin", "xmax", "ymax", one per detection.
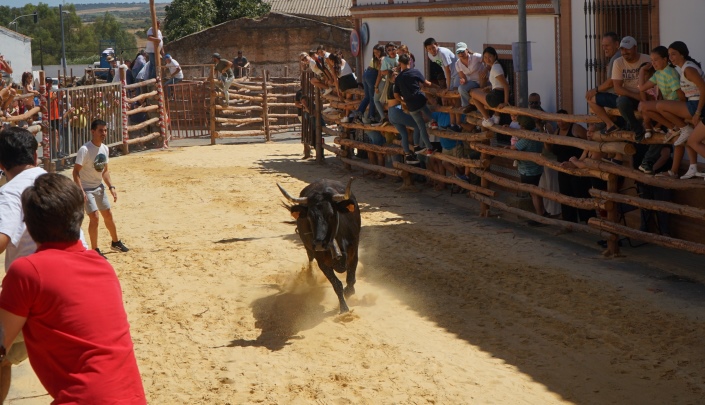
[{"xmin": 584, "ymin": 0, "xmax": 654, "ymax": 90}]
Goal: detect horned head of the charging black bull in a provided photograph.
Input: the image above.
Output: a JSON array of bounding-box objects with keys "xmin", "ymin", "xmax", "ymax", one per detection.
[{"xmin": 277, "ymin": 177, "xmax": 355, "ymax": 251}]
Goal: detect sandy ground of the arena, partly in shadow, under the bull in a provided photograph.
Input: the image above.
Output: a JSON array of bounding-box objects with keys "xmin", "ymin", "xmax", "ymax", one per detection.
[{"xmin": 8, "ymin": 143, "xmax": 705, "ymax": 404}]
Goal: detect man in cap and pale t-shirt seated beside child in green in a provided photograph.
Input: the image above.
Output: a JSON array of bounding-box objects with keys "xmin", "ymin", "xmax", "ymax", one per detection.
[{"xmin": 589, "ymin": 36, "xmax": 651, "ymax": 142}]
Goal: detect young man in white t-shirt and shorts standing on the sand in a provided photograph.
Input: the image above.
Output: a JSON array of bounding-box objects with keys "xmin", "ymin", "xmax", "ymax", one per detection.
[{"xmin": 73, "ymin": 120, "xmax": 130, "ymax": 257}]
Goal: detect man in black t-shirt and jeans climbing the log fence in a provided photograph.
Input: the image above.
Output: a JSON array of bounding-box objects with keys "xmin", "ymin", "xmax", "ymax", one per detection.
[{"xmin": 394, "ymin": 55, "xmax": 433, "ymax": 156}]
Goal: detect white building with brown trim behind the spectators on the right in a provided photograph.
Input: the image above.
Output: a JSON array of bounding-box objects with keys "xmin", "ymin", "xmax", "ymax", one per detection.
[{"xmin": 351, "ymin": 0, "xmax": 705, "ymax": 113}]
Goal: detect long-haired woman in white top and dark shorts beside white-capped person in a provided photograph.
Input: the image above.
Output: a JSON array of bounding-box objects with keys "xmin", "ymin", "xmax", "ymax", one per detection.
[{"xmin": 470, "ymin": 46, "xmax": 509, "ymax": 128}]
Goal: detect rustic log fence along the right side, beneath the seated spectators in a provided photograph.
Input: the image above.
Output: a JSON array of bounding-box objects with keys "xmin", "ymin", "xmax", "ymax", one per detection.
[{"xmin": 306, "ymin": 89, "xmax": 705, "ymax": 256}]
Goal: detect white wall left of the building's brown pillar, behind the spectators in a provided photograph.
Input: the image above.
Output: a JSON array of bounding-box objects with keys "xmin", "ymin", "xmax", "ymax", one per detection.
[{"xmin": 358, "ymin": 14, "xmax": 556, "ymax": 111}]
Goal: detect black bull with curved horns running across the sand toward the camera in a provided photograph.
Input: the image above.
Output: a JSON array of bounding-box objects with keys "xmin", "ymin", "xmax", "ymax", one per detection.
[{"xmin": 277, "ymin": 178, "xmax": 360, "ymax": 313}]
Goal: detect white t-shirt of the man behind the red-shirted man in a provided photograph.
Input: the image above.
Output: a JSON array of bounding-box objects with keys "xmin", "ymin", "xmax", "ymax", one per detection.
[{"xmin": 0, "ymin": 167, "xmax": 46, "ymax": 272}]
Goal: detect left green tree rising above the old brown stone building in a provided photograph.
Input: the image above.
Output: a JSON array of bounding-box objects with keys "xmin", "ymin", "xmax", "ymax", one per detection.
[{"xmin": 164, "ymin": 0, "xmax": 215, "ymax": 40}]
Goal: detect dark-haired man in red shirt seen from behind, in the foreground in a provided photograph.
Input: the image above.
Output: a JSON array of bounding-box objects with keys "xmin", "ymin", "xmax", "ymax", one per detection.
[{"xmin": 0, "ymin": 173, "xmax": 146, "ymax": 405}]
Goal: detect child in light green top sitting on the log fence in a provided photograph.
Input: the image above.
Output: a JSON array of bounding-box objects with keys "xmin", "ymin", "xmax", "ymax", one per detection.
[{"xmin": 639, "ymin": 46, "xmax": 686, "ymax": 141}]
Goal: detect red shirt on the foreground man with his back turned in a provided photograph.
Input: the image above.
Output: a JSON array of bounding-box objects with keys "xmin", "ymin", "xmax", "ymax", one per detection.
[{"xmin": 0, "ymin": 241, "xmax": 147, "ymax": 405}]
